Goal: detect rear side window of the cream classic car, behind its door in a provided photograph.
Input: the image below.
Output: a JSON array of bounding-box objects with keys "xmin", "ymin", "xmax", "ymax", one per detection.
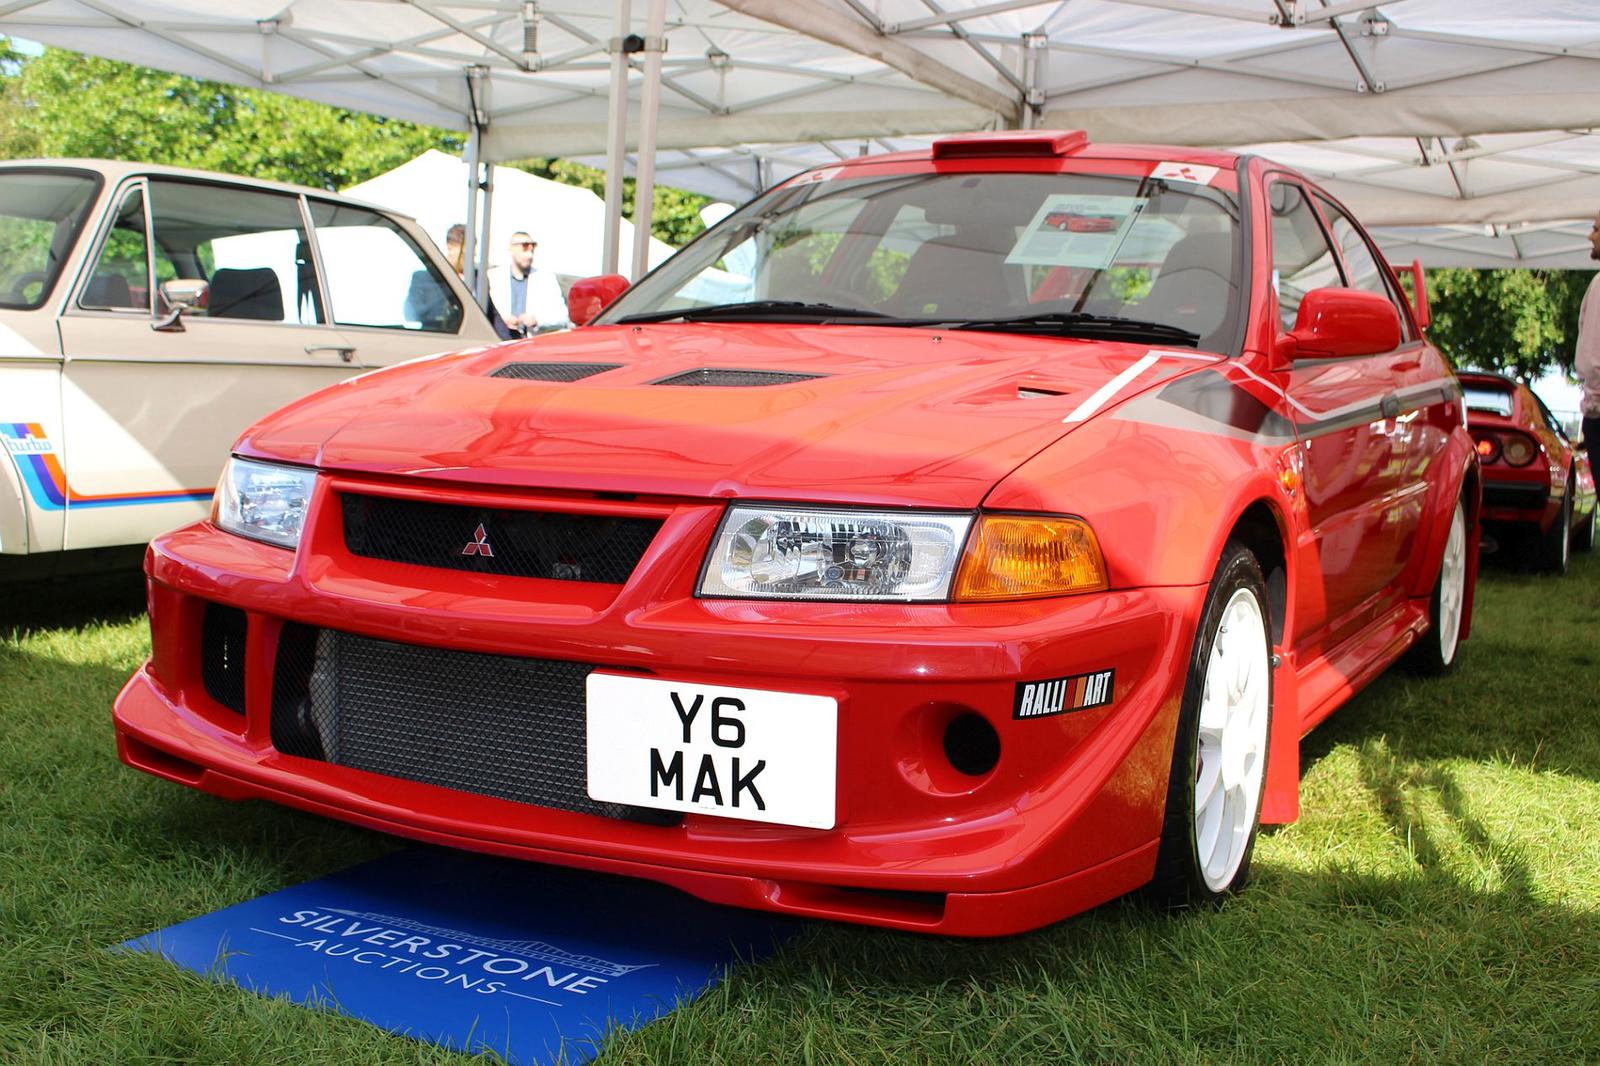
[{"xmin": 310, "ymin": 200, "xmax": 462, "ymax": 333}]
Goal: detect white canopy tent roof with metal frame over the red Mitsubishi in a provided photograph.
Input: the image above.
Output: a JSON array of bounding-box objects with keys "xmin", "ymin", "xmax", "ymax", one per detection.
[{"xmin": 0, "ymin": 0, "xmax": 1600, "ymax": 278}]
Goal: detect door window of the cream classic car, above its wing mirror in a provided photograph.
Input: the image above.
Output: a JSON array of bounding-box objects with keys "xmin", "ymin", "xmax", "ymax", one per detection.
[{"xmin": 150, "ymin": 178, "xmax": 325, "ymax": 325}]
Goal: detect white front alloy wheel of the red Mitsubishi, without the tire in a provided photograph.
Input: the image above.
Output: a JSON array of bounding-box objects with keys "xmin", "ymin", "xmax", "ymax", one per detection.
[{"xmin": 1194, "ymin": 585, "xmax": 1267, "ymax": 892}]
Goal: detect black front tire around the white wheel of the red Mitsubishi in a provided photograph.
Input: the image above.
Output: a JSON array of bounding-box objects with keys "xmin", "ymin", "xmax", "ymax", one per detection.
[{"xmin": 1150, "ymin": 541, "xmax": 1272, "ymax": 904}]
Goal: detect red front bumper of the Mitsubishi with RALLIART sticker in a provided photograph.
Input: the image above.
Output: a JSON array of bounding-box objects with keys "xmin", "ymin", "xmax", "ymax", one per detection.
[{"xmin": 115, "ymin": 476, "xmax": 1205, "ymax": 935}]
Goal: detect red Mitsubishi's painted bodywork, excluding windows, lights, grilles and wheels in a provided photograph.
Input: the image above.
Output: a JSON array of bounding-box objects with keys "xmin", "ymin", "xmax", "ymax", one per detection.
[{"xmin": 115, "ymin": 134, "xmax": 1477, "ymax": 935}]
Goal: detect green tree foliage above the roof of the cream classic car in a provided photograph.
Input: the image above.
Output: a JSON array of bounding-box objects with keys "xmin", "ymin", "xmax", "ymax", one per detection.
[{"xmin": 0, "ymin": 42, "xmax": 461, "ymax": 189}]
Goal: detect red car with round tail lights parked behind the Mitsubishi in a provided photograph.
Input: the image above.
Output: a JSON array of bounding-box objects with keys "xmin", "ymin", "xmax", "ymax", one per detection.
[{"xmin": 1458, "ymin": 371, "xmax": 1595, "ymax": 573}]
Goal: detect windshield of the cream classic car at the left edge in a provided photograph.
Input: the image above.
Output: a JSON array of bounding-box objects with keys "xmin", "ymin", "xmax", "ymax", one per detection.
[{"xmin": 0, "ymin": 170, "xmax": 101, "ymax": 311}]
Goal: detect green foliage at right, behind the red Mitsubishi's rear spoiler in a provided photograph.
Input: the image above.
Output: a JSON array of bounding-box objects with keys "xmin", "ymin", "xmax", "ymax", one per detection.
[{"xmin": 1427, "ymin": 269, "xmax": 1594, "ymax": 378}]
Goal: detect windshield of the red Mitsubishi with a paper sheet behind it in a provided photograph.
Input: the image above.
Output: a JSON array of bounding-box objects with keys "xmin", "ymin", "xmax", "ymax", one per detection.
[{"xmin": 602, "ymin": 173, "xmax": 1242, "ymax": 351}]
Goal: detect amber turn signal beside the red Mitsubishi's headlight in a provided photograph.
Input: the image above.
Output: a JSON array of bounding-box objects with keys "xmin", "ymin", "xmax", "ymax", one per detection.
[{"xmin": 952, "ymin": 514, "xmax": 1109, "ymax": 602}]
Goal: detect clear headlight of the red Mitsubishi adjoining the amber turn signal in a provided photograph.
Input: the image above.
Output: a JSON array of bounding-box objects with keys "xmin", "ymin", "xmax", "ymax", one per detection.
[{"xmin": 699, "ymin": 504, "xmax": 973, "ymax": 600}]
